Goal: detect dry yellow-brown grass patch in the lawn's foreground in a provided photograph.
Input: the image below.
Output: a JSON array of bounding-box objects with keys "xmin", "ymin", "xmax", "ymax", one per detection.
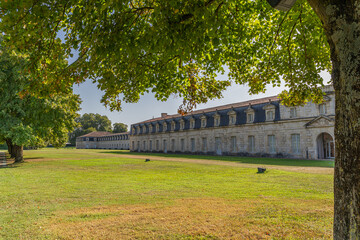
[{"xmin": 45, "ymin": 198, "xmax": 332, "ymax": 239}]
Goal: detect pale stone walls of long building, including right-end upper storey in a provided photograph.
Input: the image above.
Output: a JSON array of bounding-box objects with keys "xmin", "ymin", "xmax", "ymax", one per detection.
[{"xmin": 130, "ymin": 88, "xmax": 335, "ymax": 159}]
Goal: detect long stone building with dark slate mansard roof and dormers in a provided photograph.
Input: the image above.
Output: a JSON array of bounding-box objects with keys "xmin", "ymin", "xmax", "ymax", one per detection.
[{"xmin": 130, "ymin": 86, "xmax": 335, "ymax": 159}]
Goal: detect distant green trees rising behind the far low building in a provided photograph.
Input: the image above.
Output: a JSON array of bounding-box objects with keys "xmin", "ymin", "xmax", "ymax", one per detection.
[{"xmin": 69, "ymin": 113, "xmax": 128, "ymax": 145}]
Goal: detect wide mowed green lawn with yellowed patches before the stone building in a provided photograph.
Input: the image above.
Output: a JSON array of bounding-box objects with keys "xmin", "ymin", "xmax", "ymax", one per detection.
[{"xmin": 0, "ymin": 149, "xmax": 333, "ymax": 239}]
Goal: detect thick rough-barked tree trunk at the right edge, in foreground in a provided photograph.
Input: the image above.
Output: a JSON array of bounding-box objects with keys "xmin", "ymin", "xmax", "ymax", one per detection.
[{"xmin": 308, "ymin": 0, "xmax": 360, "ymax": 240}]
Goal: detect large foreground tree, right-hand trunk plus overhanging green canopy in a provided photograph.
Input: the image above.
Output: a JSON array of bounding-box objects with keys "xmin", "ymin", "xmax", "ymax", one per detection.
[{"xmin": 0, "ymin": 0, "xmax": 360, "ymax": 236}]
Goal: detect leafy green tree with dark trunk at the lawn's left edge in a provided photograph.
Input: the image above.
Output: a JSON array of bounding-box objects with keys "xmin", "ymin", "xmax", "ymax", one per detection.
[{"xmin": 0, "ymin": 45, "xmax": 80, "ymax": 162}]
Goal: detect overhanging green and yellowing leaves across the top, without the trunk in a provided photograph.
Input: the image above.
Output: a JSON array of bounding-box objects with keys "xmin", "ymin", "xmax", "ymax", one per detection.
[{"xmin": 0, "ymin": 0, "xmax": 330, "ymax": 112}]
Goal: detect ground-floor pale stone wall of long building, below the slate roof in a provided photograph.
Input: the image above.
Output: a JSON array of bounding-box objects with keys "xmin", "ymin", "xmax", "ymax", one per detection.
[{"xmin": 130, "ymin": 117, "xmax": 334, "ymax": 159}]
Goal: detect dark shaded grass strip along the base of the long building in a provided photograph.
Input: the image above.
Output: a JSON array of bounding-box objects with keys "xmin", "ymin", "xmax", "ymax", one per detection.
[{"xmin": 101, "ymin": 150, "xmax": 334, "ymax": 168}]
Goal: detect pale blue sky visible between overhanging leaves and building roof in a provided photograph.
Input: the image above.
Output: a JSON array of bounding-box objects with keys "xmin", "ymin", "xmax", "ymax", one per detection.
[{"xmin": 74, "ymin": 73, "xmax": 330, "ymax": 130}]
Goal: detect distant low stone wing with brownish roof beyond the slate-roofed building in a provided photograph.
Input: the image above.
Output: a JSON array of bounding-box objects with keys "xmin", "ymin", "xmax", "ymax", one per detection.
[{"xmin": 76, "ymin": 132, "xmax": 130, "ymax": 150}]
